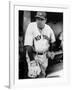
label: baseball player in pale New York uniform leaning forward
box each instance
[24,12,55,78]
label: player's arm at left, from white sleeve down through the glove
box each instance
[24,24,41,78]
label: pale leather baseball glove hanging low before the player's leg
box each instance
[28,60,41,78]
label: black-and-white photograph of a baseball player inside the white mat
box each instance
[18,10,63,79]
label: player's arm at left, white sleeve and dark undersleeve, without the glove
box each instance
[24,24,34,61]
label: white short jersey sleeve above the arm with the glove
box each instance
[24,24,33,46]
